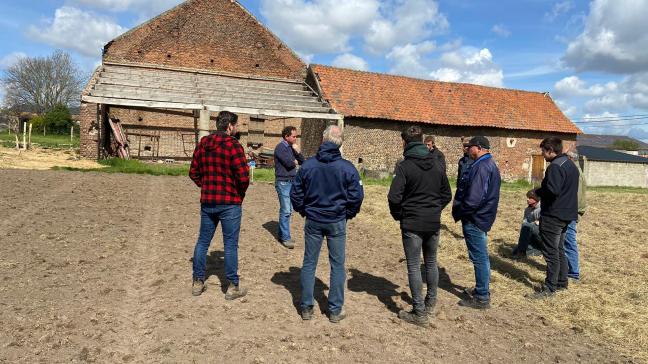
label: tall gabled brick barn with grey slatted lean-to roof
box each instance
[79,0,340,160]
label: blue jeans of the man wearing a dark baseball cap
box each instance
[462,221,490,300]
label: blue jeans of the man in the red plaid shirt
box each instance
[193,203,242,286]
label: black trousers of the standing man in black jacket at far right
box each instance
[540,216,570,292]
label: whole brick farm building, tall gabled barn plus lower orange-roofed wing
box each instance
[79,0,580,180]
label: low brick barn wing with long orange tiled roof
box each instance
[309,65,581,180]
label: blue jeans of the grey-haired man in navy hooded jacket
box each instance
[301,219,346,315]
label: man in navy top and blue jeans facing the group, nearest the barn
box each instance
[274,126,304,249]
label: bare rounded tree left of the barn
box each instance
[2,50,85,113]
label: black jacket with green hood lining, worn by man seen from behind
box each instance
[387,142,452,232]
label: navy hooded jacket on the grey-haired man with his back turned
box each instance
[290,142,364,224]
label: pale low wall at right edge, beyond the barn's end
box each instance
[583,160,648,188]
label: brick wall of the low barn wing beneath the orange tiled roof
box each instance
[343,118,576,180]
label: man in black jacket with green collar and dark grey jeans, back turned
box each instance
[387,126,452,326]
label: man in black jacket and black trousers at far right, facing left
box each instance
[530,137,579,299]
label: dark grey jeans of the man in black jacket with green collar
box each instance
[401,230,439,314]
